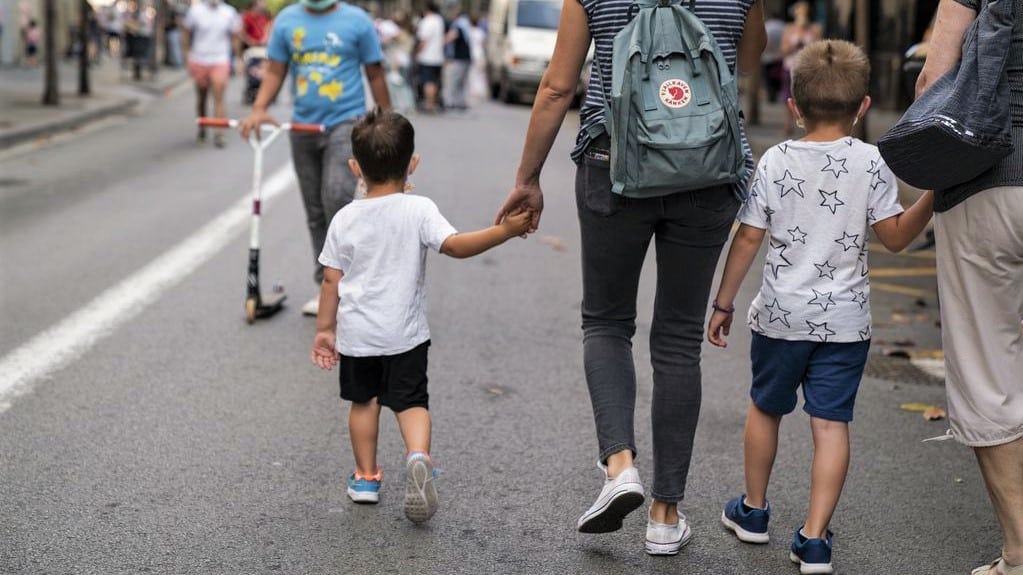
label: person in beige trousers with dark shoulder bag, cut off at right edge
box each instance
[917,0,1023,575]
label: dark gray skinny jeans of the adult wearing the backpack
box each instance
[576,138,739,503]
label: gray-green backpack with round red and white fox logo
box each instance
[590,0,746,197]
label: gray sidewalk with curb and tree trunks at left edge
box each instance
[0,57,187,149]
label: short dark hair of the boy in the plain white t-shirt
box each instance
[352,108,415,183]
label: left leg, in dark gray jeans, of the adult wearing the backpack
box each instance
[576,152,654,477]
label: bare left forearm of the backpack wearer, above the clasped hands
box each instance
[516,77,575,185]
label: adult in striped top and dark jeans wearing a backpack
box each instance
[497,0,764,555]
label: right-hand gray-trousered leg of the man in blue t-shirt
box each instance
[319,121,358,283]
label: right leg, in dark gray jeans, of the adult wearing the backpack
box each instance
[650,186,739,523]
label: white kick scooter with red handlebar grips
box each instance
[196,118,323,323]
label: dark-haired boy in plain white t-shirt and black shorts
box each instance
[312,112,530,523]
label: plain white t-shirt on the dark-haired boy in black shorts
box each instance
[319,193,456,357]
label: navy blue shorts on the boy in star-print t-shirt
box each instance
[750,331,871,422]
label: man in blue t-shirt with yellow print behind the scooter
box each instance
[241,0,391,316]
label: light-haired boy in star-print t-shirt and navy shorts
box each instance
[707,40,932,574]
